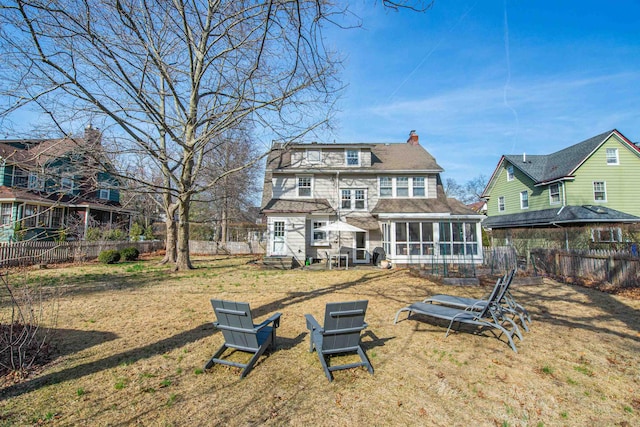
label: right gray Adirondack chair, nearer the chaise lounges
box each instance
[304,300,373,382]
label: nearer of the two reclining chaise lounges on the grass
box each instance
[393,280,522,353]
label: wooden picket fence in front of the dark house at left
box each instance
[0,240,164,268]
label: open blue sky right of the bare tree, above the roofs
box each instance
[327,0,640,184]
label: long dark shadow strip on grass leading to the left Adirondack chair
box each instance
[0,323,212,400]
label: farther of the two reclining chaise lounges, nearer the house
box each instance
[422,269,531,332]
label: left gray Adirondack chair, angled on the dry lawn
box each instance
[204,299,281,378]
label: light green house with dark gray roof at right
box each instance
[482,129,640,241]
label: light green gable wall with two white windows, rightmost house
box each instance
[566,136,640,216]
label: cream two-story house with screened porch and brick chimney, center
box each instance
[262,132,483,264]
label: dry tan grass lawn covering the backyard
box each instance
[0,258,640,426]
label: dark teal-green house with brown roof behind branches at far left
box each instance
[0,126,130,242]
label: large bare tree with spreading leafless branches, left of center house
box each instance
[0,0,341,269]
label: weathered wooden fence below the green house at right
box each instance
[531,249,640,288]
